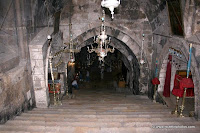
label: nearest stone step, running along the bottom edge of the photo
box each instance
[1,126,200,133]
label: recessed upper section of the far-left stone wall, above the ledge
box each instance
[0,0,20,72]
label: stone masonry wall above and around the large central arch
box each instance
[60,0,152,92]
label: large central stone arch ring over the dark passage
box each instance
[69,26,149,94]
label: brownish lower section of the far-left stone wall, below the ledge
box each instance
[0,62,35,123]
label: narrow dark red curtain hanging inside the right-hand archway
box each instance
[163,55,172,97]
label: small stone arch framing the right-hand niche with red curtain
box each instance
[158,37,200,117]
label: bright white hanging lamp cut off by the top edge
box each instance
[101,0,120,19]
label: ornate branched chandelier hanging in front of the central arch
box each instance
[87,10,115,61]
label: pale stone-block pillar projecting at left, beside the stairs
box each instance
[29,28,53,108]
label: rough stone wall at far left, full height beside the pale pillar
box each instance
[0,0,51,123]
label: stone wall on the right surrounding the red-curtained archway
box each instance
[149,0,200,119]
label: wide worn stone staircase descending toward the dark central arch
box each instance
[0,89,200,133]
